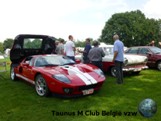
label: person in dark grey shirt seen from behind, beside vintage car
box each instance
[88,41,105,70]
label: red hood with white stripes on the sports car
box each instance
[37,64,100,85]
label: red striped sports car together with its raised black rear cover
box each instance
[10,35,105,96]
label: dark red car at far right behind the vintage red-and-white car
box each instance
[125,46,161,71]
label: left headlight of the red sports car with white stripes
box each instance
[53,74,71,84]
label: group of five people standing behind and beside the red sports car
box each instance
[55,34,124,84]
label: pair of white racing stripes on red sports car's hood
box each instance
[63,66,97,85]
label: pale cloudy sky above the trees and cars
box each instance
[0,0,161,42]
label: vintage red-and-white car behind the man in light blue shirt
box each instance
[76,44,148,76]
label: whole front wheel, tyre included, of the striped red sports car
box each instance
[35,74,50,97]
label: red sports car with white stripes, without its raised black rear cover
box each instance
[11,54,105,96]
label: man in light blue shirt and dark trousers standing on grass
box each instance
[113,34,124,84]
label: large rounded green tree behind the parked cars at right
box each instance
[100,10,159,46]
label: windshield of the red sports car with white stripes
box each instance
[34,55,75,67]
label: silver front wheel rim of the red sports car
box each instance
[35,77,47,96]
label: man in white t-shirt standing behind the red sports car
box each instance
[64,35,76,61]
